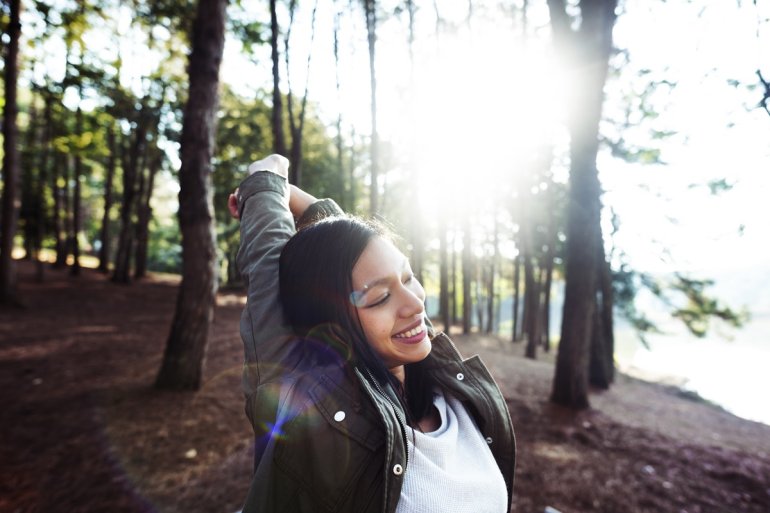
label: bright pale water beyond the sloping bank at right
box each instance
[615,267,770,425]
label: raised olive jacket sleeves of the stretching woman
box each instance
[236,171,342,394]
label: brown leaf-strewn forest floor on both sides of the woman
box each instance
[0,262,770,513]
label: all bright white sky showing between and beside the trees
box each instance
[223,0,770,273]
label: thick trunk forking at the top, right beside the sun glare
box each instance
[548,0,617,409]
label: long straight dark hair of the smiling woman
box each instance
[279,216,433,424]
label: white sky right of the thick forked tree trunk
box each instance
[602,1,770,273]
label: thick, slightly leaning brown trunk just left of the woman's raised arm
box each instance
[155,0,227,390]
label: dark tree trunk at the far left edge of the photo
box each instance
[0,0,21,304]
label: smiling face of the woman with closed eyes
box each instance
[351,237,431,382]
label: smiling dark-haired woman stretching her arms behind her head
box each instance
[229,155,515,513]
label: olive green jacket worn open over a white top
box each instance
[238,172,515,513]
